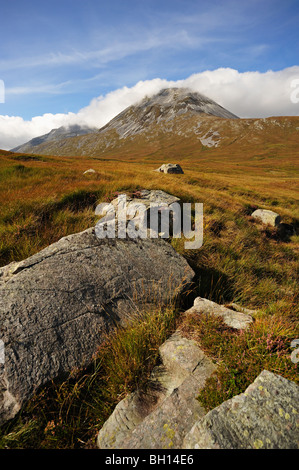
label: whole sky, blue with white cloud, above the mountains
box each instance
[0,0,299,149]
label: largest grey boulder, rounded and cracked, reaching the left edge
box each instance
[0,228,194,424]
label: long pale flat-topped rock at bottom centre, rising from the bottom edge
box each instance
[97,331,216,449]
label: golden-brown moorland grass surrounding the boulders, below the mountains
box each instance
[0,149,299,448]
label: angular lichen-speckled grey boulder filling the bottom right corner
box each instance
[183,370,299,449]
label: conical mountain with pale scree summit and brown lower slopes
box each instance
[9,88,299,161]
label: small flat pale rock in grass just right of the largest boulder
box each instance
[186,297,253,330]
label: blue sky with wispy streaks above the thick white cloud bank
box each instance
[0,0,299,119]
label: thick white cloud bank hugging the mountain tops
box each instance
[0,66,299,149]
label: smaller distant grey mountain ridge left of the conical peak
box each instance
[11,124,97,153]
